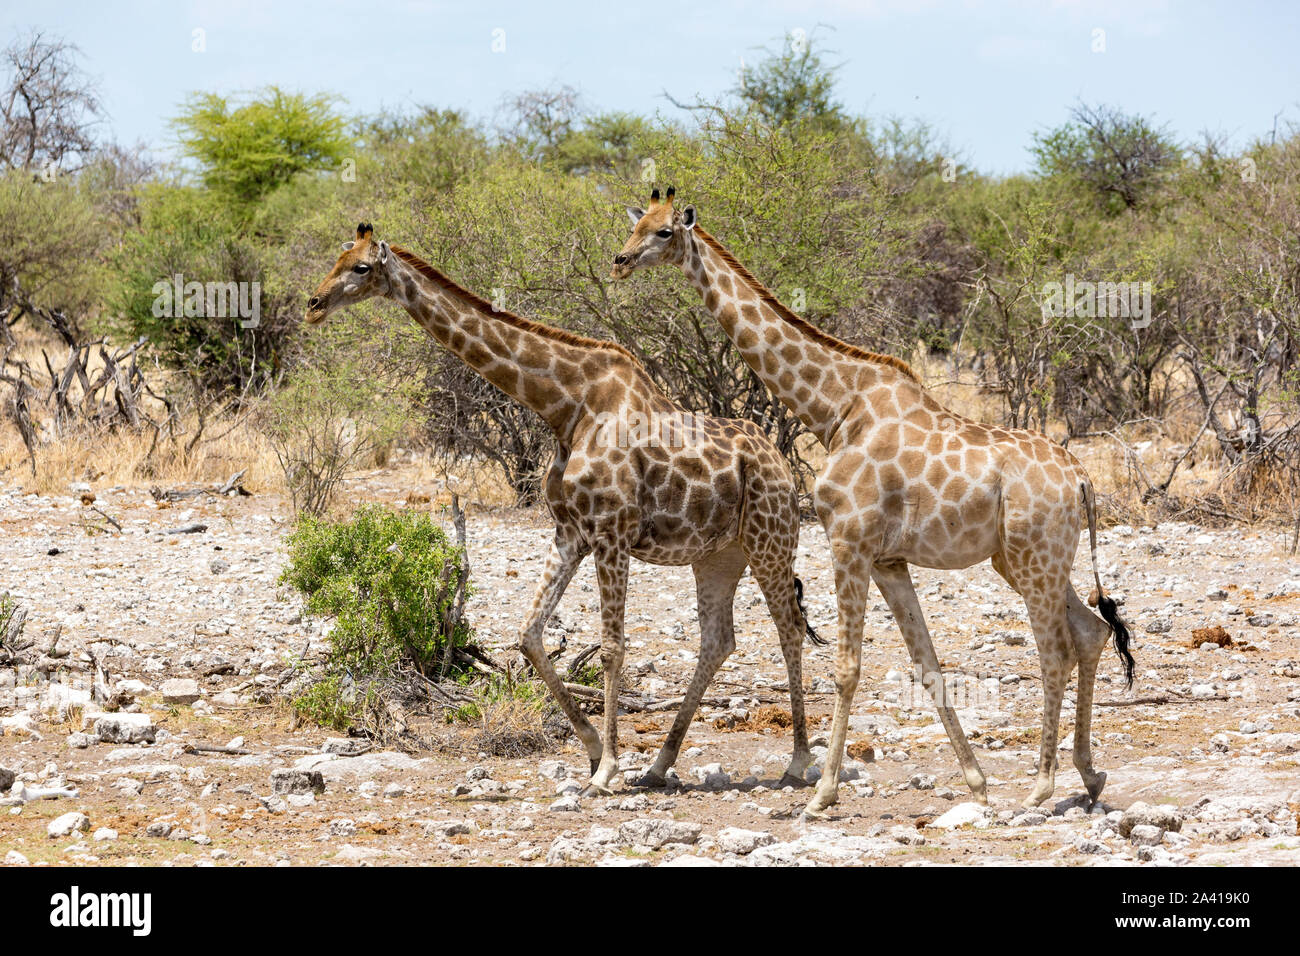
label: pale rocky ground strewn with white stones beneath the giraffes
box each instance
[0,473,1300,866]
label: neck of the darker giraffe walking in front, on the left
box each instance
[386,247,593,442]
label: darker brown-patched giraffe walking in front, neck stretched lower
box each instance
[304,222,826,793]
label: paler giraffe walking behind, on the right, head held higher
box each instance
[611,189,1134,817]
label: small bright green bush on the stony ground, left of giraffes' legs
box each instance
[281,506,472,727]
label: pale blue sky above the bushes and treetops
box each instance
[0,0,1300,173]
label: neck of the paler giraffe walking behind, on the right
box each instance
[681,226,872,447]
